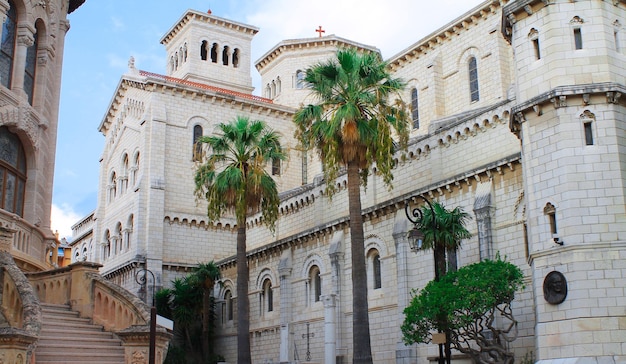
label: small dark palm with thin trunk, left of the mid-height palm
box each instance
[193,261,222,362]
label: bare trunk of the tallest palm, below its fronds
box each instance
[348,163,372,364]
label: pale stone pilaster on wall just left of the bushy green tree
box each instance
[393,215,417,364]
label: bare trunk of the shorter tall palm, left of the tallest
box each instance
[237,226,252,364]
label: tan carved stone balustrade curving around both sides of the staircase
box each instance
[0,242,172,364]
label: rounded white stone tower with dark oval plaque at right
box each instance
[503,0,626,363]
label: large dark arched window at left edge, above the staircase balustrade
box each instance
[0,126,26,216]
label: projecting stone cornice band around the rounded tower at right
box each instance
[509,82,626,137]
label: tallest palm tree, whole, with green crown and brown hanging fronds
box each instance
[294,49,408,363]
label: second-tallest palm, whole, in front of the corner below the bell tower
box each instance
[195,116,286,363]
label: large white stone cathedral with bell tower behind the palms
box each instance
[70,0,626,364]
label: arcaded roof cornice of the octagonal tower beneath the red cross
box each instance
[254,34,380,71]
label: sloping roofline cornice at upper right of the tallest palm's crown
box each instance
[388,0,509,70]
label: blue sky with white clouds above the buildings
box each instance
[51,0,483,240]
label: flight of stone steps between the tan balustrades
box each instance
[35,303,124,364]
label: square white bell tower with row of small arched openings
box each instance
[161,10,258,93]
